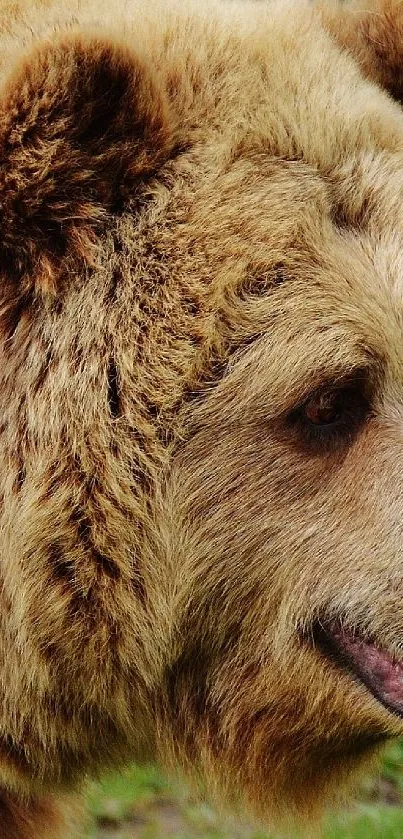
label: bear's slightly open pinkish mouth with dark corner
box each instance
[313,621,403,717]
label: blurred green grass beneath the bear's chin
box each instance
[86,741,403,839]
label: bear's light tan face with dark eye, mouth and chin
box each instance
[161,156,403,810]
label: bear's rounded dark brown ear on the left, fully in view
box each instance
[0,33,174,291]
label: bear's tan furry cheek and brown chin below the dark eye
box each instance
[155,423,403,807]
